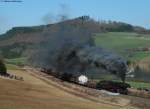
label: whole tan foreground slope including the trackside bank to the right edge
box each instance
[0,66,149,109]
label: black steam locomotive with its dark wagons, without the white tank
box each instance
[41,69,131,95]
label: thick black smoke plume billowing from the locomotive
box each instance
[30,16,127,81]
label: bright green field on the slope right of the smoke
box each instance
[94,32,150,61]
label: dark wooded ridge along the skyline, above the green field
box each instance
[0,16,148,58]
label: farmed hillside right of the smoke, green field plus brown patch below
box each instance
[95,32,150,81]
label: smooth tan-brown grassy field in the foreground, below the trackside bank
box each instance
[0,69,119,109]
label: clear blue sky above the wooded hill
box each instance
[0,0,150,33]
